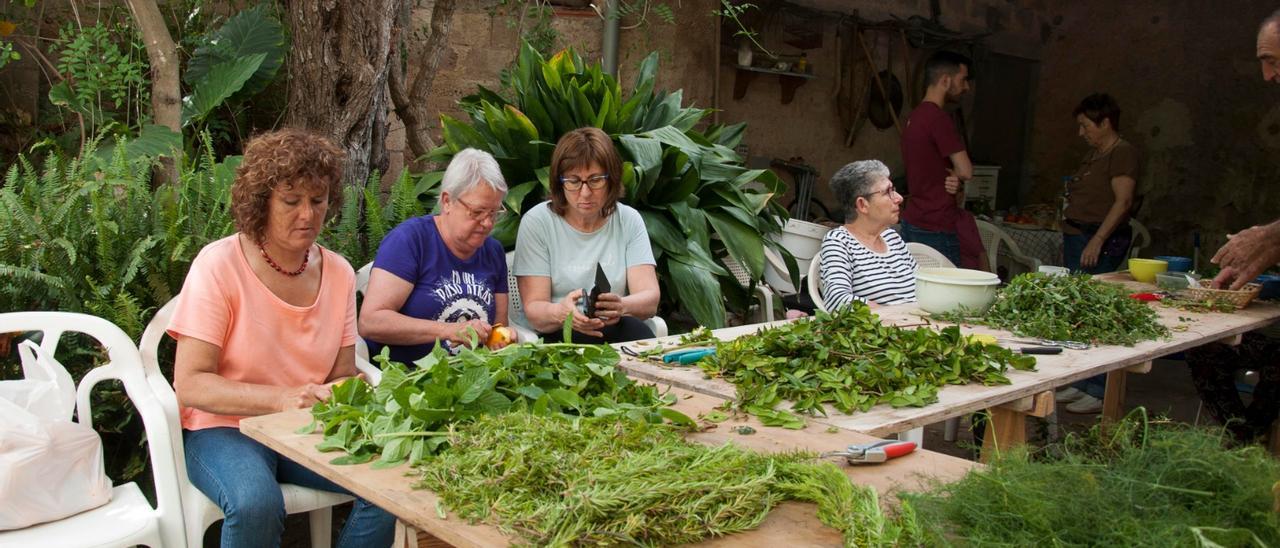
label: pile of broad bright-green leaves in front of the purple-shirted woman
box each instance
[303,343,694,467]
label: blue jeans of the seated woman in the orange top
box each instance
[182,428,396,548]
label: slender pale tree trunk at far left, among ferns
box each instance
[129,0,182,183]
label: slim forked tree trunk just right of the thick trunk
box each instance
[388,0,457,159]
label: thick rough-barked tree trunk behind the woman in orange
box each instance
[284,0,403,186]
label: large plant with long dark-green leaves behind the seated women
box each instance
[431,44,794,326]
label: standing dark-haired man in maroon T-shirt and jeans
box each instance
[902,51,973,265]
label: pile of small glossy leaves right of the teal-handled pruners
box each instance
[700,303,1036,429]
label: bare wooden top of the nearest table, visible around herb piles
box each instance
[241,388,975,547]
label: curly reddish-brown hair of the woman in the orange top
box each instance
[232,128,346,242]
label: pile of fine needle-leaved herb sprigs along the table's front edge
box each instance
[415,414,914,545]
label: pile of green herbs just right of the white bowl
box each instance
[932,273,1169,346]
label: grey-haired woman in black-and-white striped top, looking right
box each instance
[818,160,916,310]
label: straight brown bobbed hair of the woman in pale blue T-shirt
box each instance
[550,127,622,216]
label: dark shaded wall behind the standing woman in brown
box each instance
[1027,0,1280,257]
